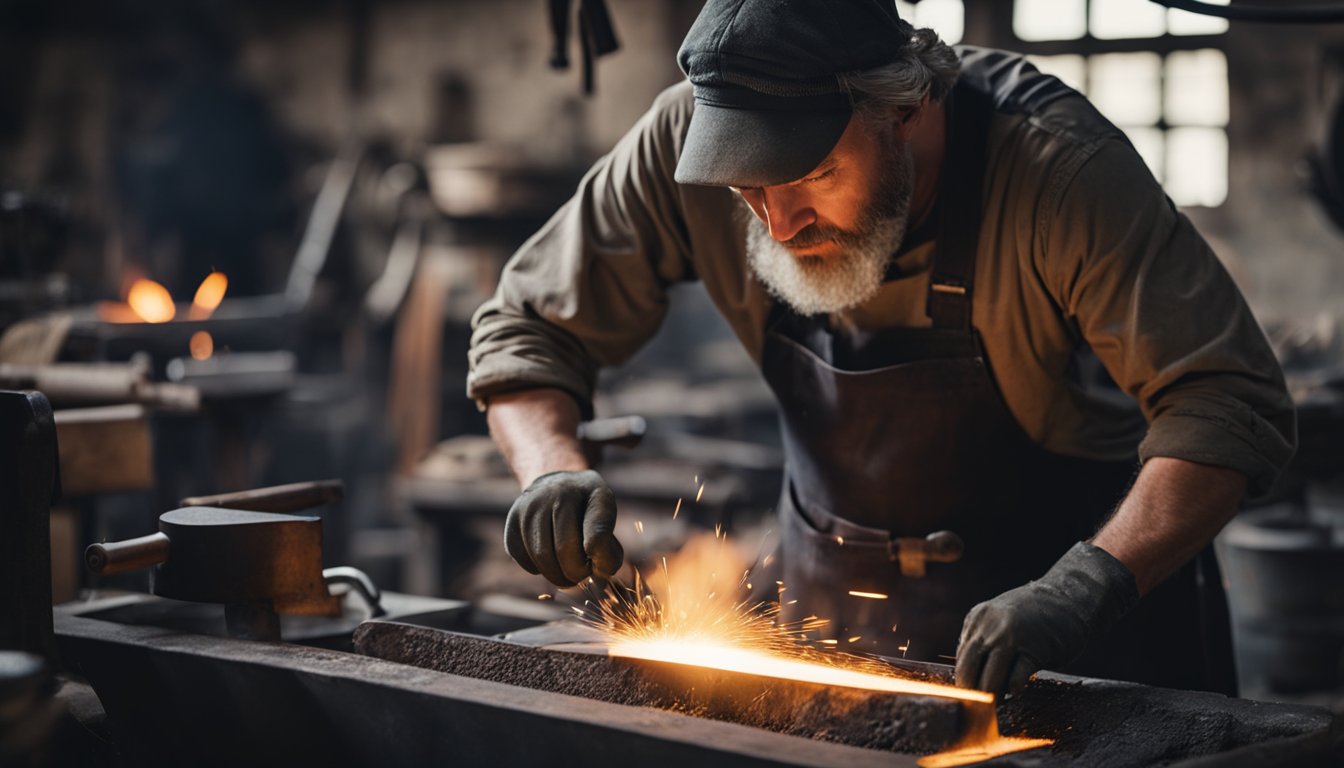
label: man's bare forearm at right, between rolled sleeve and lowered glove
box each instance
[1091,456,1246,594]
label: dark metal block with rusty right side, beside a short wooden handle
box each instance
[153,507,339,613]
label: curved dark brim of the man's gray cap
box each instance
[675,102,852,187]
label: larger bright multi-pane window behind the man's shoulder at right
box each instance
[1013,0,1228,207]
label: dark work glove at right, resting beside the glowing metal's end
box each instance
[957,542,1138,694]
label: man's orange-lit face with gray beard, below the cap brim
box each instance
[738,110,914,315]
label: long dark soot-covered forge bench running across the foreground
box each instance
[55,599,1344,768]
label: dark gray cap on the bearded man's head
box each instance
[675,0,914,187]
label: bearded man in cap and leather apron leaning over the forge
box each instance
[468,0,1294,693]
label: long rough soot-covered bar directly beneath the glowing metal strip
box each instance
[355,621,962,755]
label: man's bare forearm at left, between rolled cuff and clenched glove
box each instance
[485,389,589,488]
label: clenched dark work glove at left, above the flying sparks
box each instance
[504,469,625,586]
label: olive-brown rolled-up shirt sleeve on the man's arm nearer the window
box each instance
[1043,139,1296,496]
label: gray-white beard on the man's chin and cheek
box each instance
[743,147,914,315]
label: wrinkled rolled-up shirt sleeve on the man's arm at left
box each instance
[466,89,694,412]
